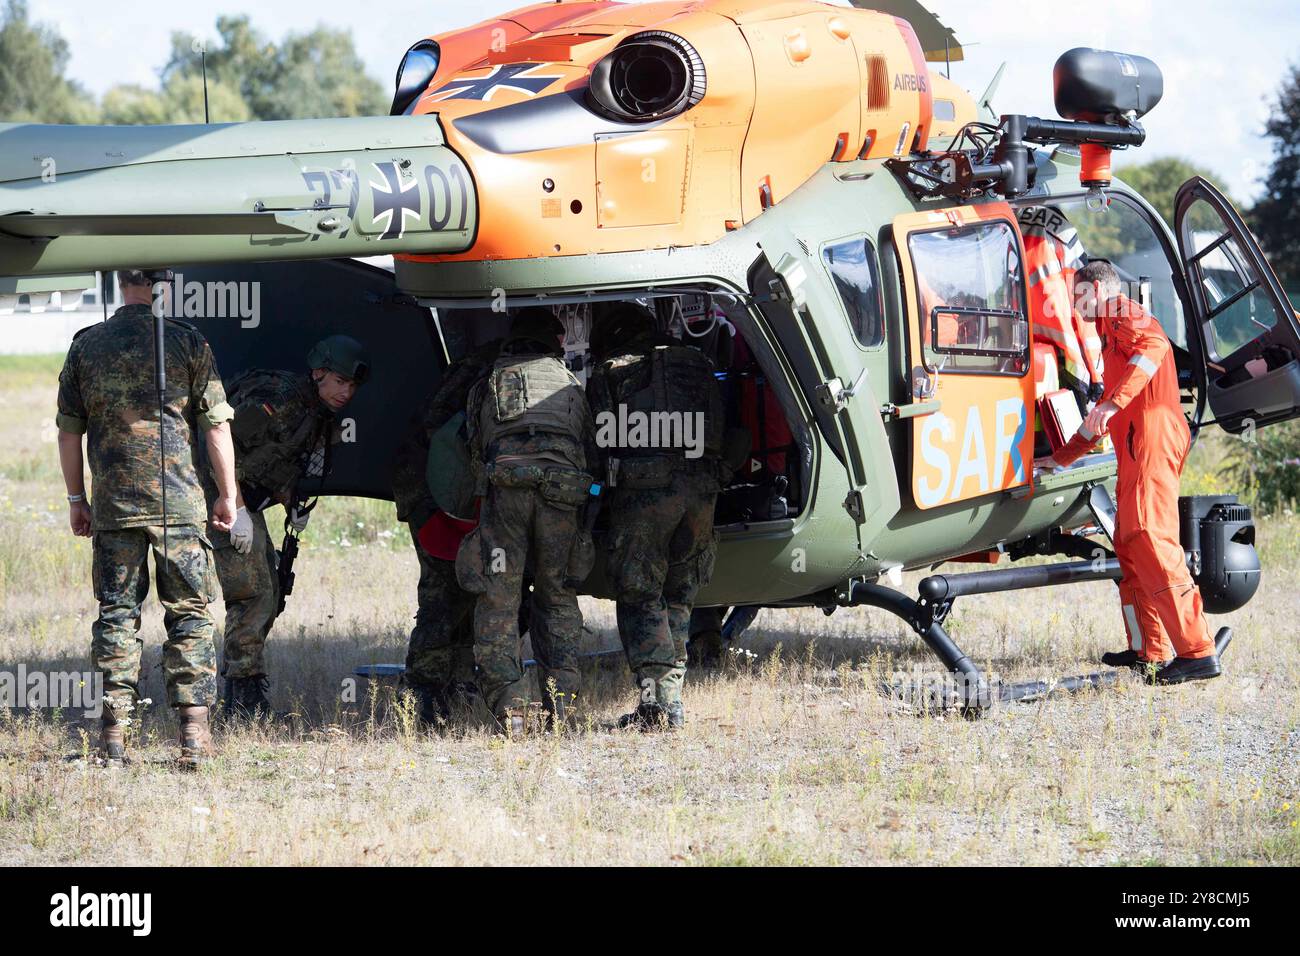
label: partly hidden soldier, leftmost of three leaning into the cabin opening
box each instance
[393,339,501,724]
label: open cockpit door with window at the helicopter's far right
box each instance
[1174,177,1300,433]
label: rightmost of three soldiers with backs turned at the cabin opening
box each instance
[588,303,725,730]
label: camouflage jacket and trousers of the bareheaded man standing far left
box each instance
[56,306,233,714]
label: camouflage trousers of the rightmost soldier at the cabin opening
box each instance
[608,472,718,705]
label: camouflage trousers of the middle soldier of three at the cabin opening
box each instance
[456,484,590,717]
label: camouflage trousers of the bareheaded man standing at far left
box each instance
[91,524,217,715]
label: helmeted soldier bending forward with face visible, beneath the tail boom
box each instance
[204,336,371,717]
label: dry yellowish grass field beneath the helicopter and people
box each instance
[0,358,1300,865]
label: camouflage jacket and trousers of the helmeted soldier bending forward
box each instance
[203,368,339,679]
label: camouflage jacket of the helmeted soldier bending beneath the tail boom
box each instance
[220,368,341,509]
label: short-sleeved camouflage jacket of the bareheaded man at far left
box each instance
[55,306,234,531]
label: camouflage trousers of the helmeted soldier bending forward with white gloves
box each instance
[212,511,280,679]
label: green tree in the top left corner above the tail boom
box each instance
[0,0,99,124]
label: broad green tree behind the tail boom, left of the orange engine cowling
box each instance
[163,16,390,121]
